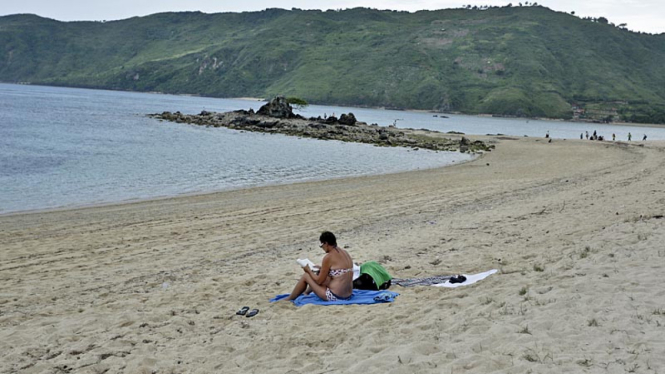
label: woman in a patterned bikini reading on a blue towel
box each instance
[287,231,353,301]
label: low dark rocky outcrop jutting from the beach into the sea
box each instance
[150,106,494,153]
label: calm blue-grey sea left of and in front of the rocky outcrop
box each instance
[0,84,471,214]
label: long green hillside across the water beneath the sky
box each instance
[0,6,665,123]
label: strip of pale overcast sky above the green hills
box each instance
[0,0,665,34]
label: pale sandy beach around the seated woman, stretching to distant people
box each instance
[0,137,665,373]
